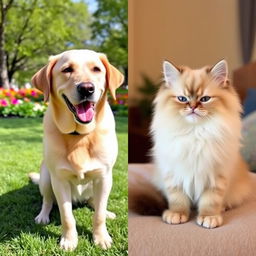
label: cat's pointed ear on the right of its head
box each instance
[210,60,228,86]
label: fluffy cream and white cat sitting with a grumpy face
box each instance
[151,60,250,228]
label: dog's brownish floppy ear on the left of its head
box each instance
[31,55,58,101]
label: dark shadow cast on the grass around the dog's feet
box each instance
[0,183,92,243]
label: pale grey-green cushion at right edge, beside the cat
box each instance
[241,111,256,171]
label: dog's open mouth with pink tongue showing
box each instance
[62,94,95,124]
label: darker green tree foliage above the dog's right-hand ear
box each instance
[91,0,128,82]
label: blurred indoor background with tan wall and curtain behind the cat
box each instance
[128,0,256,163]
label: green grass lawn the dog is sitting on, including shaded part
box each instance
[0,117,128,256]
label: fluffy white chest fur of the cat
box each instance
[158,123,233,202]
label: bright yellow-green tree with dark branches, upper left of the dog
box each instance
[0,0,90,87]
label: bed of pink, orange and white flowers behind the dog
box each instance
[0,88,128,117]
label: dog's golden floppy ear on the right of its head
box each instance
[100,53,124,99]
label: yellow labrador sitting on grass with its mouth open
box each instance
[30,50,123,250]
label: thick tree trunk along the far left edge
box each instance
[0,3,10,89]
